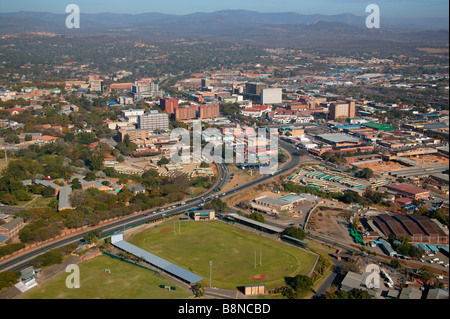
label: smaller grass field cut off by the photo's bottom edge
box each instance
[21,256,193,299]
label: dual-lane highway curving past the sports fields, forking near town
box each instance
[0,141,300,272]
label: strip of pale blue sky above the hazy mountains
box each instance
[0,0,449,18]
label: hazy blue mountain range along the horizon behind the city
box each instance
[0,10,448,45]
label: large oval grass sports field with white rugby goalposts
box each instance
[126,221,317,290]
